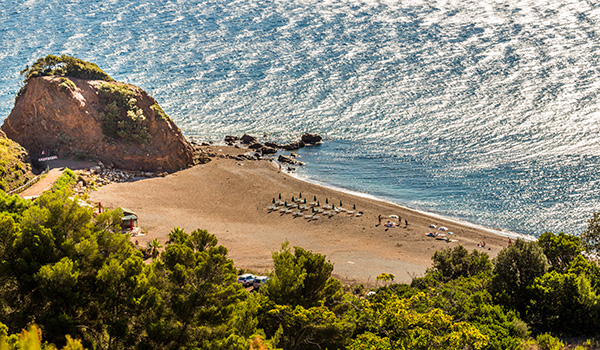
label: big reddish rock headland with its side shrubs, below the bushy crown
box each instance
[2,76,194,172]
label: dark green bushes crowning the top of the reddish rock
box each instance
[21,55,114,81]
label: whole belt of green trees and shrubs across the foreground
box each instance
[0,189,600,350]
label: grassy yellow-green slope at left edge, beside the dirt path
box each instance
[0,137,33,191]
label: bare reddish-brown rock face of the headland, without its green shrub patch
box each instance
[2,77,193,172]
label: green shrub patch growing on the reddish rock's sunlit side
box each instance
[98,83,150,144]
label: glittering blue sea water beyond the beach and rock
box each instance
[0,0,600,235]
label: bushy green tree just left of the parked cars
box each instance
[146,228,247,349]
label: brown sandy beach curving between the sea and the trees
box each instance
[90,146,508,286]
